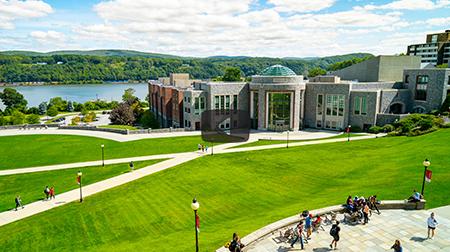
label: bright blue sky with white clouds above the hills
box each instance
[0,0,450,57]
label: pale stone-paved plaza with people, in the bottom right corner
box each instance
[245,206,450,252]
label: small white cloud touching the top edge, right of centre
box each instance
[268,0,336,12]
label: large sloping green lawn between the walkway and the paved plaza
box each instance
[0,129,450,251]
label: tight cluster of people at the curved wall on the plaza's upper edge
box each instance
[345,195,380,225]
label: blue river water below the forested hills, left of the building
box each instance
[0,83,148,108]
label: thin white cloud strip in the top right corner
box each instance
[363,0,450,10]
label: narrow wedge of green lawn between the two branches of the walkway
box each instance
[0,160,162,212]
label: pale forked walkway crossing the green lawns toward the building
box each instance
[0,135,384,226]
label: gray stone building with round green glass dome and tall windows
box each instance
[151,60,450,131]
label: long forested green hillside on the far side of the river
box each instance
[0,50,369,83]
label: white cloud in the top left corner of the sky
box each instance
[0,0,53,29]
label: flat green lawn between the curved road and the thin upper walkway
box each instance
[0,135,202,170]
